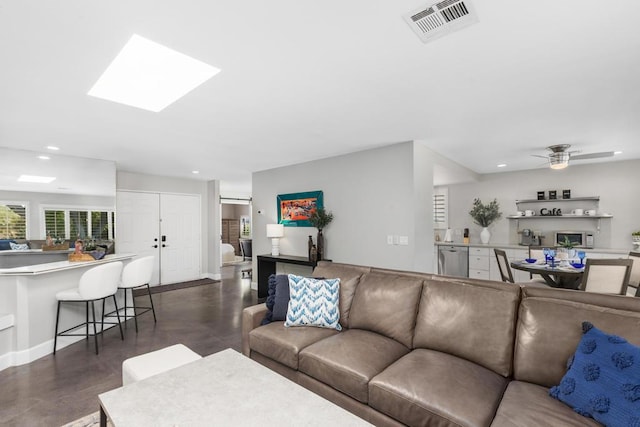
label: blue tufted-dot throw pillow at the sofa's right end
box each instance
[549,322,640,427]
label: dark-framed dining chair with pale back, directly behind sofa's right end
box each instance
[580,258,633,295]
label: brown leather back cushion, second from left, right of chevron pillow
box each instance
[349,273,423,347]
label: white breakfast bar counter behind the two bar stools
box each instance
[0,254,135,370]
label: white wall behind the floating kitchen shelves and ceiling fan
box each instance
[441,160,640,251]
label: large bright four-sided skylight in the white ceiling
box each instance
[89,34,220,112]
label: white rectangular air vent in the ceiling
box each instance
[403,0,478,43]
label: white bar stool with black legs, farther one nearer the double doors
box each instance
[107,255,157,333]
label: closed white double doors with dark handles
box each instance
[116,191,202,285]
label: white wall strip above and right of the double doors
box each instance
[116,171,220,278]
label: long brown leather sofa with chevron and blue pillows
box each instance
[242,262,640,427]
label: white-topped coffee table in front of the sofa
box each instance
[98,349,371,427]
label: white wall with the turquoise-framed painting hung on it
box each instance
[252,142,433,271]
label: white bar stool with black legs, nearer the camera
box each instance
[53,261,124,354]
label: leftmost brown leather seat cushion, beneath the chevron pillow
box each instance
[249,322,338,369]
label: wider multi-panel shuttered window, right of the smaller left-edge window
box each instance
[44,208,115,240]
